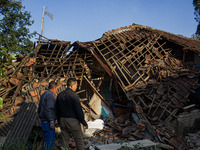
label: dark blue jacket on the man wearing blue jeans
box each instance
[38,90,56,121]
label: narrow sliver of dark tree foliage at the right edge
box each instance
[193,0,200,39]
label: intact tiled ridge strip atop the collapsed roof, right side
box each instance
[102,24,200,52]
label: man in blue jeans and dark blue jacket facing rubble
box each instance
[38,81,57,150]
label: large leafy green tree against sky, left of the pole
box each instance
[0,0,35,54]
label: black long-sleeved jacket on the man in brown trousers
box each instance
[56,88,87,126]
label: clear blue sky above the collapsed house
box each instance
[22,0,197,43]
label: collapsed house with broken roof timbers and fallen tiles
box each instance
[0,24,200,149]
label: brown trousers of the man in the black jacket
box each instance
[60,118,85,150]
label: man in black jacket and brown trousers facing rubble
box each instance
[56,78,88,150]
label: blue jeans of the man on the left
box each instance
[41,120,55,150]
